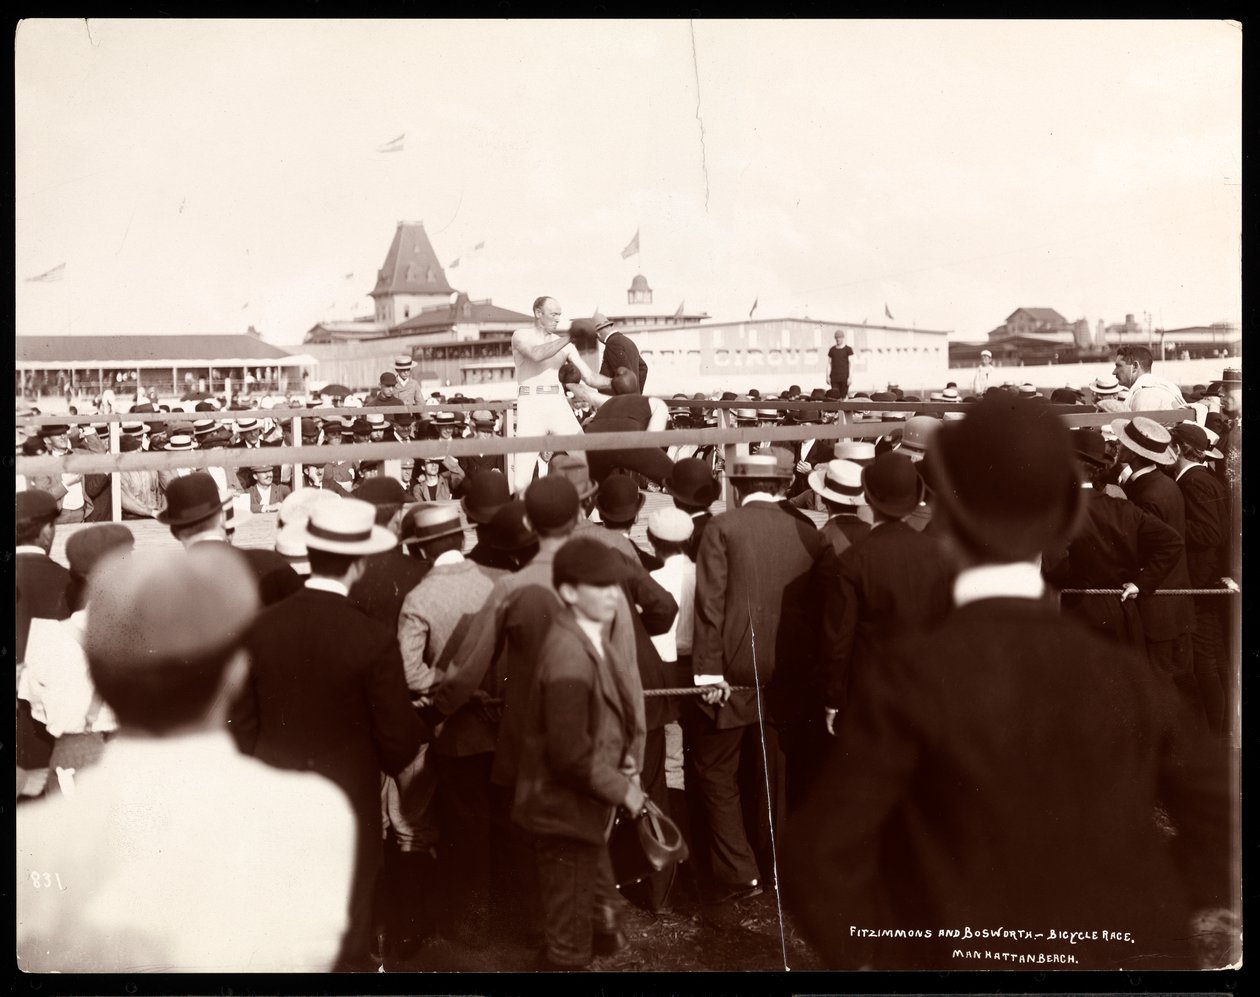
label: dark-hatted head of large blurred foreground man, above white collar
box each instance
[929,395,1085,562]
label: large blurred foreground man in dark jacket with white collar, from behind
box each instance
[781,397,1240,971]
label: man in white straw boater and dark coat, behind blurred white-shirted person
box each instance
[235,496,431,972]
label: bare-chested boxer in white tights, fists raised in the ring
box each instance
[508,296,612,492]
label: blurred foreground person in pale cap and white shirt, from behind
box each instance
[16,545,354,973]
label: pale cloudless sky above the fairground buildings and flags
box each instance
[15,20,1242,345]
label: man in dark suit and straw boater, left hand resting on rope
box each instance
[684,449,825,902]
